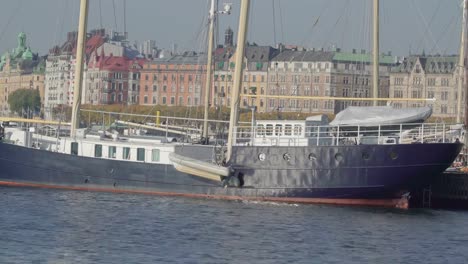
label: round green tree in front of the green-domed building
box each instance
[8,89,41,115]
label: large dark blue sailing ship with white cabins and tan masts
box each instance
[0,0,462,208]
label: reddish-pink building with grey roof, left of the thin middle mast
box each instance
[139,52,207,106]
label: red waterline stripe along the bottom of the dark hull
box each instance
[0,181,408,209]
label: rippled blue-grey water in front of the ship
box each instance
[0,188,468,264]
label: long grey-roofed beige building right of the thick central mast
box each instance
[266,48,394,114]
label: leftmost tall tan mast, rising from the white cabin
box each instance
[71,0,88,138]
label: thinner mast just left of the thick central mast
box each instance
[203,0,216,143]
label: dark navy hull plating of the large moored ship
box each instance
[0,143,461,207]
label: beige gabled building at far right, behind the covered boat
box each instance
[390,56,465,117]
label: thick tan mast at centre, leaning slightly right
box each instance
[226,0,250,160]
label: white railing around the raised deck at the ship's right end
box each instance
[234,123,462,146]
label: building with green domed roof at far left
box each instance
[0,32,45,116]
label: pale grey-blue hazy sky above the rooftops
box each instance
[0,0,462,55]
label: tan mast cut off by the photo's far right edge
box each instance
[457,0,468,124]
